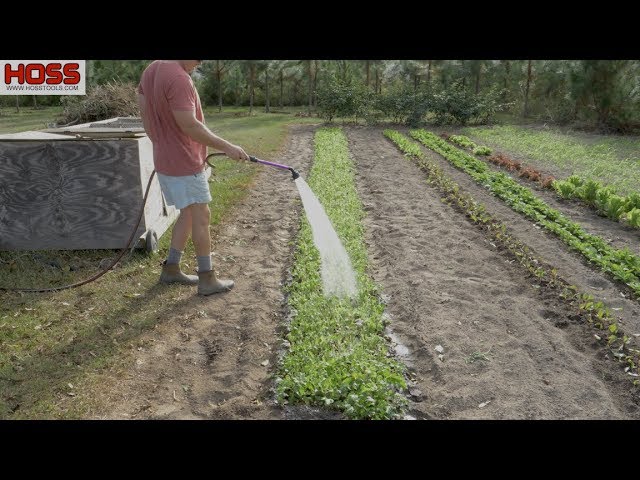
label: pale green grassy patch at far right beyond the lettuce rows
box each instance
[462,125,640,195]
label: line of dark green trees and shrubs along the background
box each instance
[5,60,640,133]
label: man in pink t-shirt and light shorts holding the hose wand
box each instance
[138,60,249,295]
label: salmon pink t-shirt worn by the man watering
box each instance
[138,60,207,176]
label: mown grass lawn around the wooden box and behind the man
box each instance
[0,104,317,419]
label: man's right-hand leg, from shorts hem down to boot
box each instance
[189,203,234,295]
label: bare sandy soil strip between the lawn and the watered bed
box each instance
[96,127,313,419]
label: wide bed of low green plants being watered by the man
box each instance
[276,128,406,419]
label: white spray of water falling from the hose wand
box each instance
[296,177,358,297]
